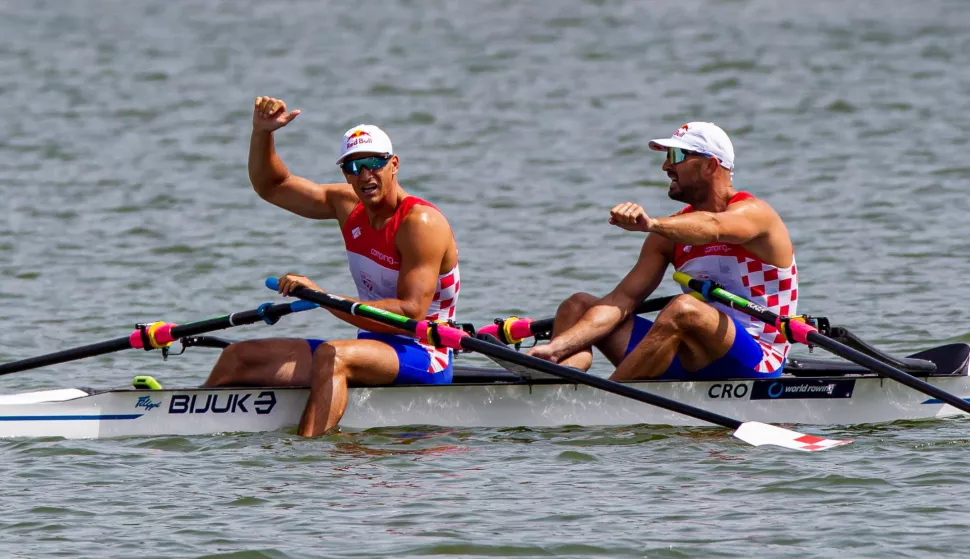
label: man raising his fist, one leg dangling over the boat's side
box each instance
[205,97,460,436]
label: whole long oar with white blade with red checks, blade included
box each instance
[266,278,851,451]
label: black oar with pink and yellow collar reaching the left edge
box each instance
[0,301,318,375]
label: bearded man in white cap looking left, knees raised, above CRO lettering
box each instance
[530,122,798,380]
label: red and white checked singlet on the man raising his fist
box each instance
[341,196,460,372]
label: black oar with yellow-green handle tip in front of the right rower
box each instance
[674,272,970,413]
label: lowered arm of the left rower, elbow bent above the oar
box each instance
[322,206,452,334]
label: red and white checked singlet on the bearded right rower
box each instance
[674,192,798,373]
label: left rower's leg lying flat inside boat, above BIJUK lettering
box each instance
[203,338,311,386]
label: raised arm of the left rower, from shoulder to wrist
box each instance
[249,130,357,223]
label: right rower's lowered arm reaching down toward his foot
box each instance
[552,235,673,357]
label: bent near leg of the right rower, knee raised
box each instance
[610,295,737,380]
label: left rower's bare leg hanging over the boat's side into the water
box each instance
[297,340,398,437]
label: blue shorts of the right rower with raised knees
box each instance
[624,316,785,380]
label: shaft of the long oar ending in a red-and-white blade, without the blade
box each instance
[266,278,742,429]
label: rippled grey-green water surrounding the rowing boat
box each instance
[0,0,970,558]
